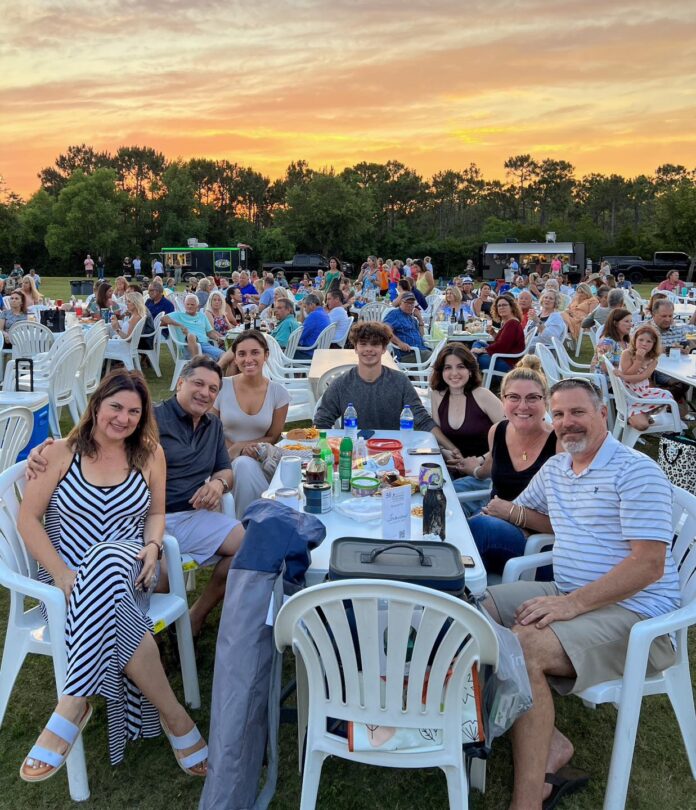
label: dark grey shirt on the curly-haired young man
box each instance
[314,367,435,430]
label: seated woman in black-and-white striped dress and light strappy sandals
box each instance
[18,370,207,782]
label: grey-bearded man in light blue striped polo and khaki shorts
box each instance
[484,379,681,808]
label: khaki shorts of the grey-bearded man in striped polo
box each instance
[488,582,675,695]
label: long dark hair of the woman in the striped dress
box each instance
[67,369,159,470]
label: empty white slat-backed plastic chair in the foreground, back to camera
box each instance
[275,579,498,810]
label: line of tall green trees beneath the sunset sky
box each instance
[0,144,696,275]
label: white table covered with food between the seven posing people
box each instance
[270,430,486,595]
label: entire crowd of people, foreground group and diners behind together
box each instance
[2,257,694,808]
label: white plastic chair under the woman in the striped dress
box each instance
[0,462,201,801]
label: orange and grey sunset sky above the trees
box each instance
[0,0,696,196]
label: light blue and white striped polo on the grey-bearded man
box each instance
[515,434,681,616]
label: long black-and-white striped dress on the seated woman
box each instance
[39,454,160,765]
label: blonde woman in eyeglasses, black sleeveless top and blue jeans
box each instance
[469,354,561,574]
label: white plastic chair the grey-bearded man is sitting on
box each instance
[503,487,696,810]
